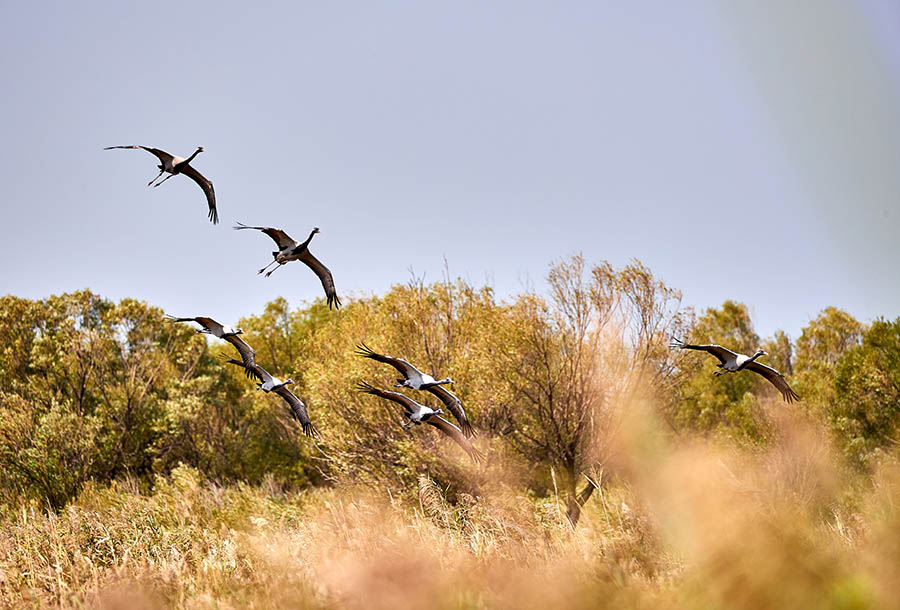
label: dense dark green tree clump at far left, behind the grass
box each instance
[0,291,316,507]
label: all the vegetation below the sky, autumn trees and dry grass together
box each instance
[0,256,900,608]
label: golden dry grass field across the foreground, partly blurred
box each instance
[0,406,900,609]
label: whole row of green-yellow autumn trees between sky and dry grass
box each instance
[0,255,900,523]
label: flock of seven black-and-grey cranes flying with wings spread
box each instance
[104,145,800,463]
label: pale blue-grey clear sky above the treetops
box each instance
[0,0,900,337]
